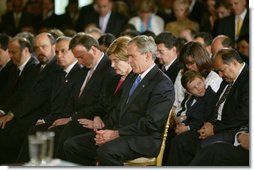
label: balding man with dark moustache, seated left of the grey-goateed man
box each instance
[0,37,38,163]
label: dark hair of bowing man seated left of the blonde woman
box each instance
[69,33,100,50]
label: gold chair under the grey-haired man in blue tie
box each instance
[124,107,175,166]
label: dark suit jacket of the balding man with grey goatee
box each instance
[11,58,61,122]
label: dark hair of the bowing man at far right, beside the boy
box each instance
[215,48,243,64]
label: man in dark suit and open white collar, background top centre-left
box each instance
[76,0,127,36]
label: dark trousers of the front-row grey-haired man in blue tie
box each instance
[64,132,141,166]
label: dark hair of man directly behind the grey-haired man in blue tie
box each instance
[155,32,179,51]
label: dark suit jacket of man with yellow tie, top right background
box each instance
[215,10,249,41]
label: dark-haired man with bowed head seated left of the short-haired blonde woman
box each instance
[42,34,116,159]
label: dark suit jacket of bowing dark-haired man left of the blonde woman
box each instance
[63,55,116,120]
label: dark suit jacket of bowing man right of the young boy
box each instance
[214,64,249,133]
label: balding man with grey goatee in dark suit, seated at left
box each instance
[0,33,59,162]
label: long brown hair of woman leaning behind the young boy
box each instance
[179,42,212,77]
